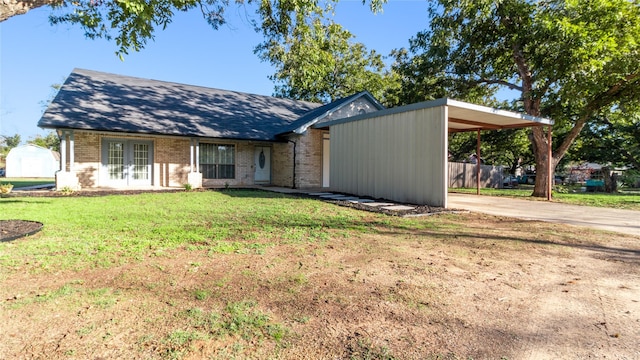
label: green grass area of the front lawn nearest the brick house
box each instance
[0,190,404,271]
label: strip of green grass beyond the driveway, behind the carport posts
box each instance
[449,185,640,211]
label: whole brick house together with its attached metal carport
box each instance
[38,69,553,207]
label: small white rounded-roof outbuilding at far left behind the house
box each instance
[5,144,60,178]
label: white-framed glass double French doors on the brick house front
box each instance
[102,139,153,187]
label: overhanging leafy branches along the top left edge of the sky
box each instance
[0,0,386,58]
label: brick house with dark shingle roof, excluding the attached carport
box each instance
[38,69,383,189]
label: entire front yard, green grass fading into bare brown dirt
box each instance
[0,190,640,359]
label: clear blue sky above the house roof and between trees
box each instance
[0,0,427,142]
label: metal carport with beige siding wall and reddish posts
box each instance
[318,98,553,207]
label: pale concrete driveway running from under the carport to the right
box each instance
[448,193,640,236]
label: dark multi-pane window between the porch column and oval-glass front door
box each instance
[200,144,236,179]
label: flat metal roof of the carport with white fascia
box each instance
[318,98,553,132]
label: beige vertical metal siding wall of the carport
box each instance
[331,106,448,206]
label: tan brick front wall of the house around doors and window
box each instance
[63,129,327,189]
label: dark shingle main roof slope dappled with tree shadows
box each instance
[38,69,322,140]
